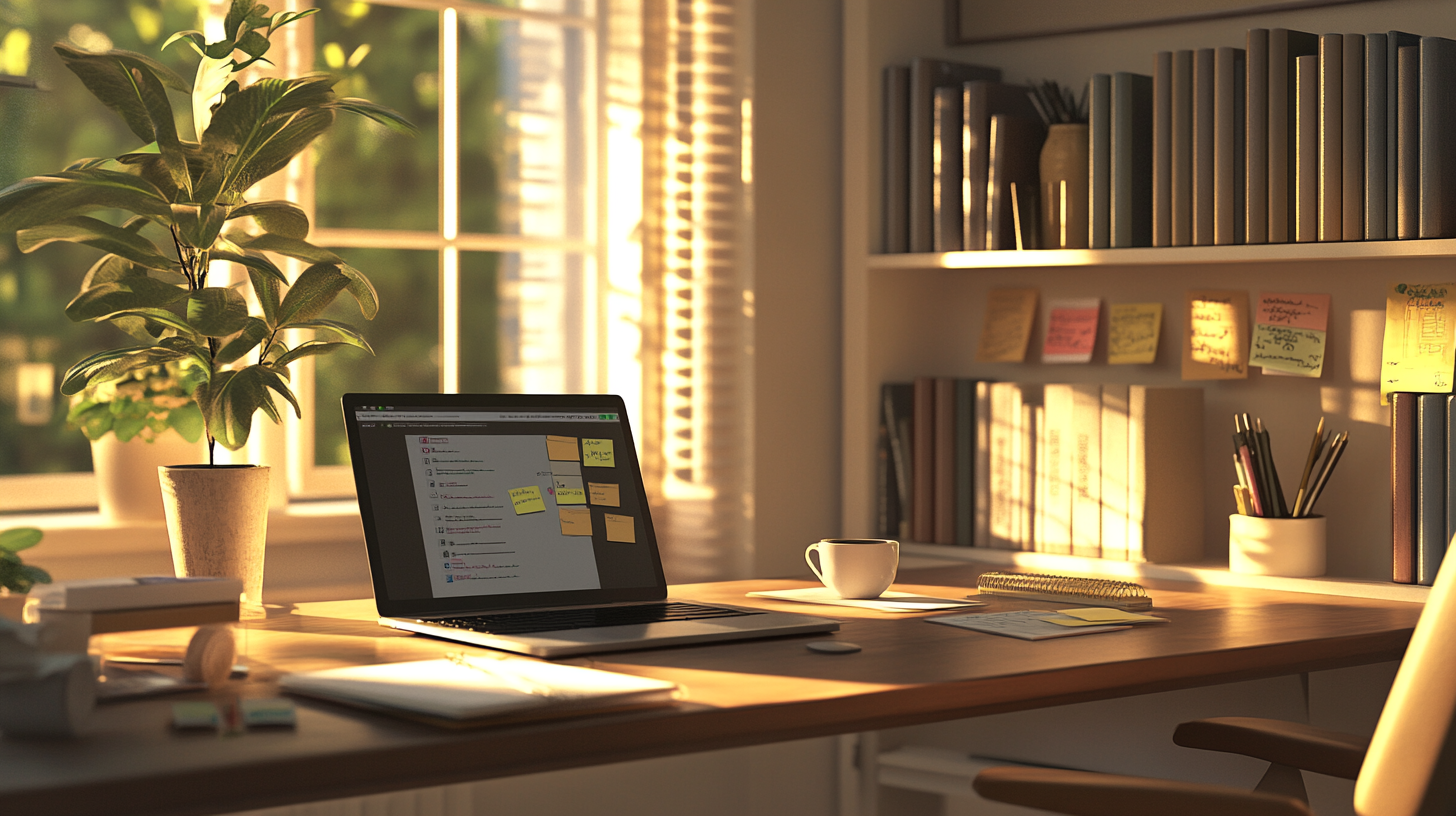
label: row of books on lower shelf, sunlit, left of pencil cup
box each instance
[878,377,1203,562]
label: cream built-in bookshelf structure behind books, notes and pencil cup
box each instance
[842,0,1456,588]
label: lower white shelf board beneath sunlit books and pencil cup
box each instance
[900,542,1431,603]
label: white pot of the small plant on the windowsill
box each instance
[92,428,207,522]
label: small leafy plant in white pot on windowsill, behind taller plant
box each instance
[66,360,205,522]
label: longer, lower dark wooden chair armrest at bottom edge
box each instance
[971,768,1312,816]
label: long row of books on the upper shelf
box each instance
[882,29,1456,252]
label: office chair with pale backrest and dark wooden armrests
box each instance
[973,554,1456,816]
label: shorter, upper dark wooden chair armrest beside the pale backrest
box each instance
[1174,717,1370,780]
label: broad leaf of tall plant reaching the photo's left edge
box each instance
[0,168,172,232]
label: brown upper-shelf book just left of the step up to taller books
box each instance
[1213,47,1245,245]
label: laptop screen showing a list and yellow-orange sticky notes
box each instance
[344,393,665,616]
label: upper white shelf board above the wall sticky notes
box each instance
[866,238,1456,270]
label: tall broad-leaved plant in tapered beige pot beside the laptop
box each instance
[0,0,414,603]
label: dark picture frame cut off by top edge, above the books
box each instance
[945,0,1372,45]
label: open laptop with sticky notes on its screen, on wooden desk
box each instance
[344,393,839,657]
